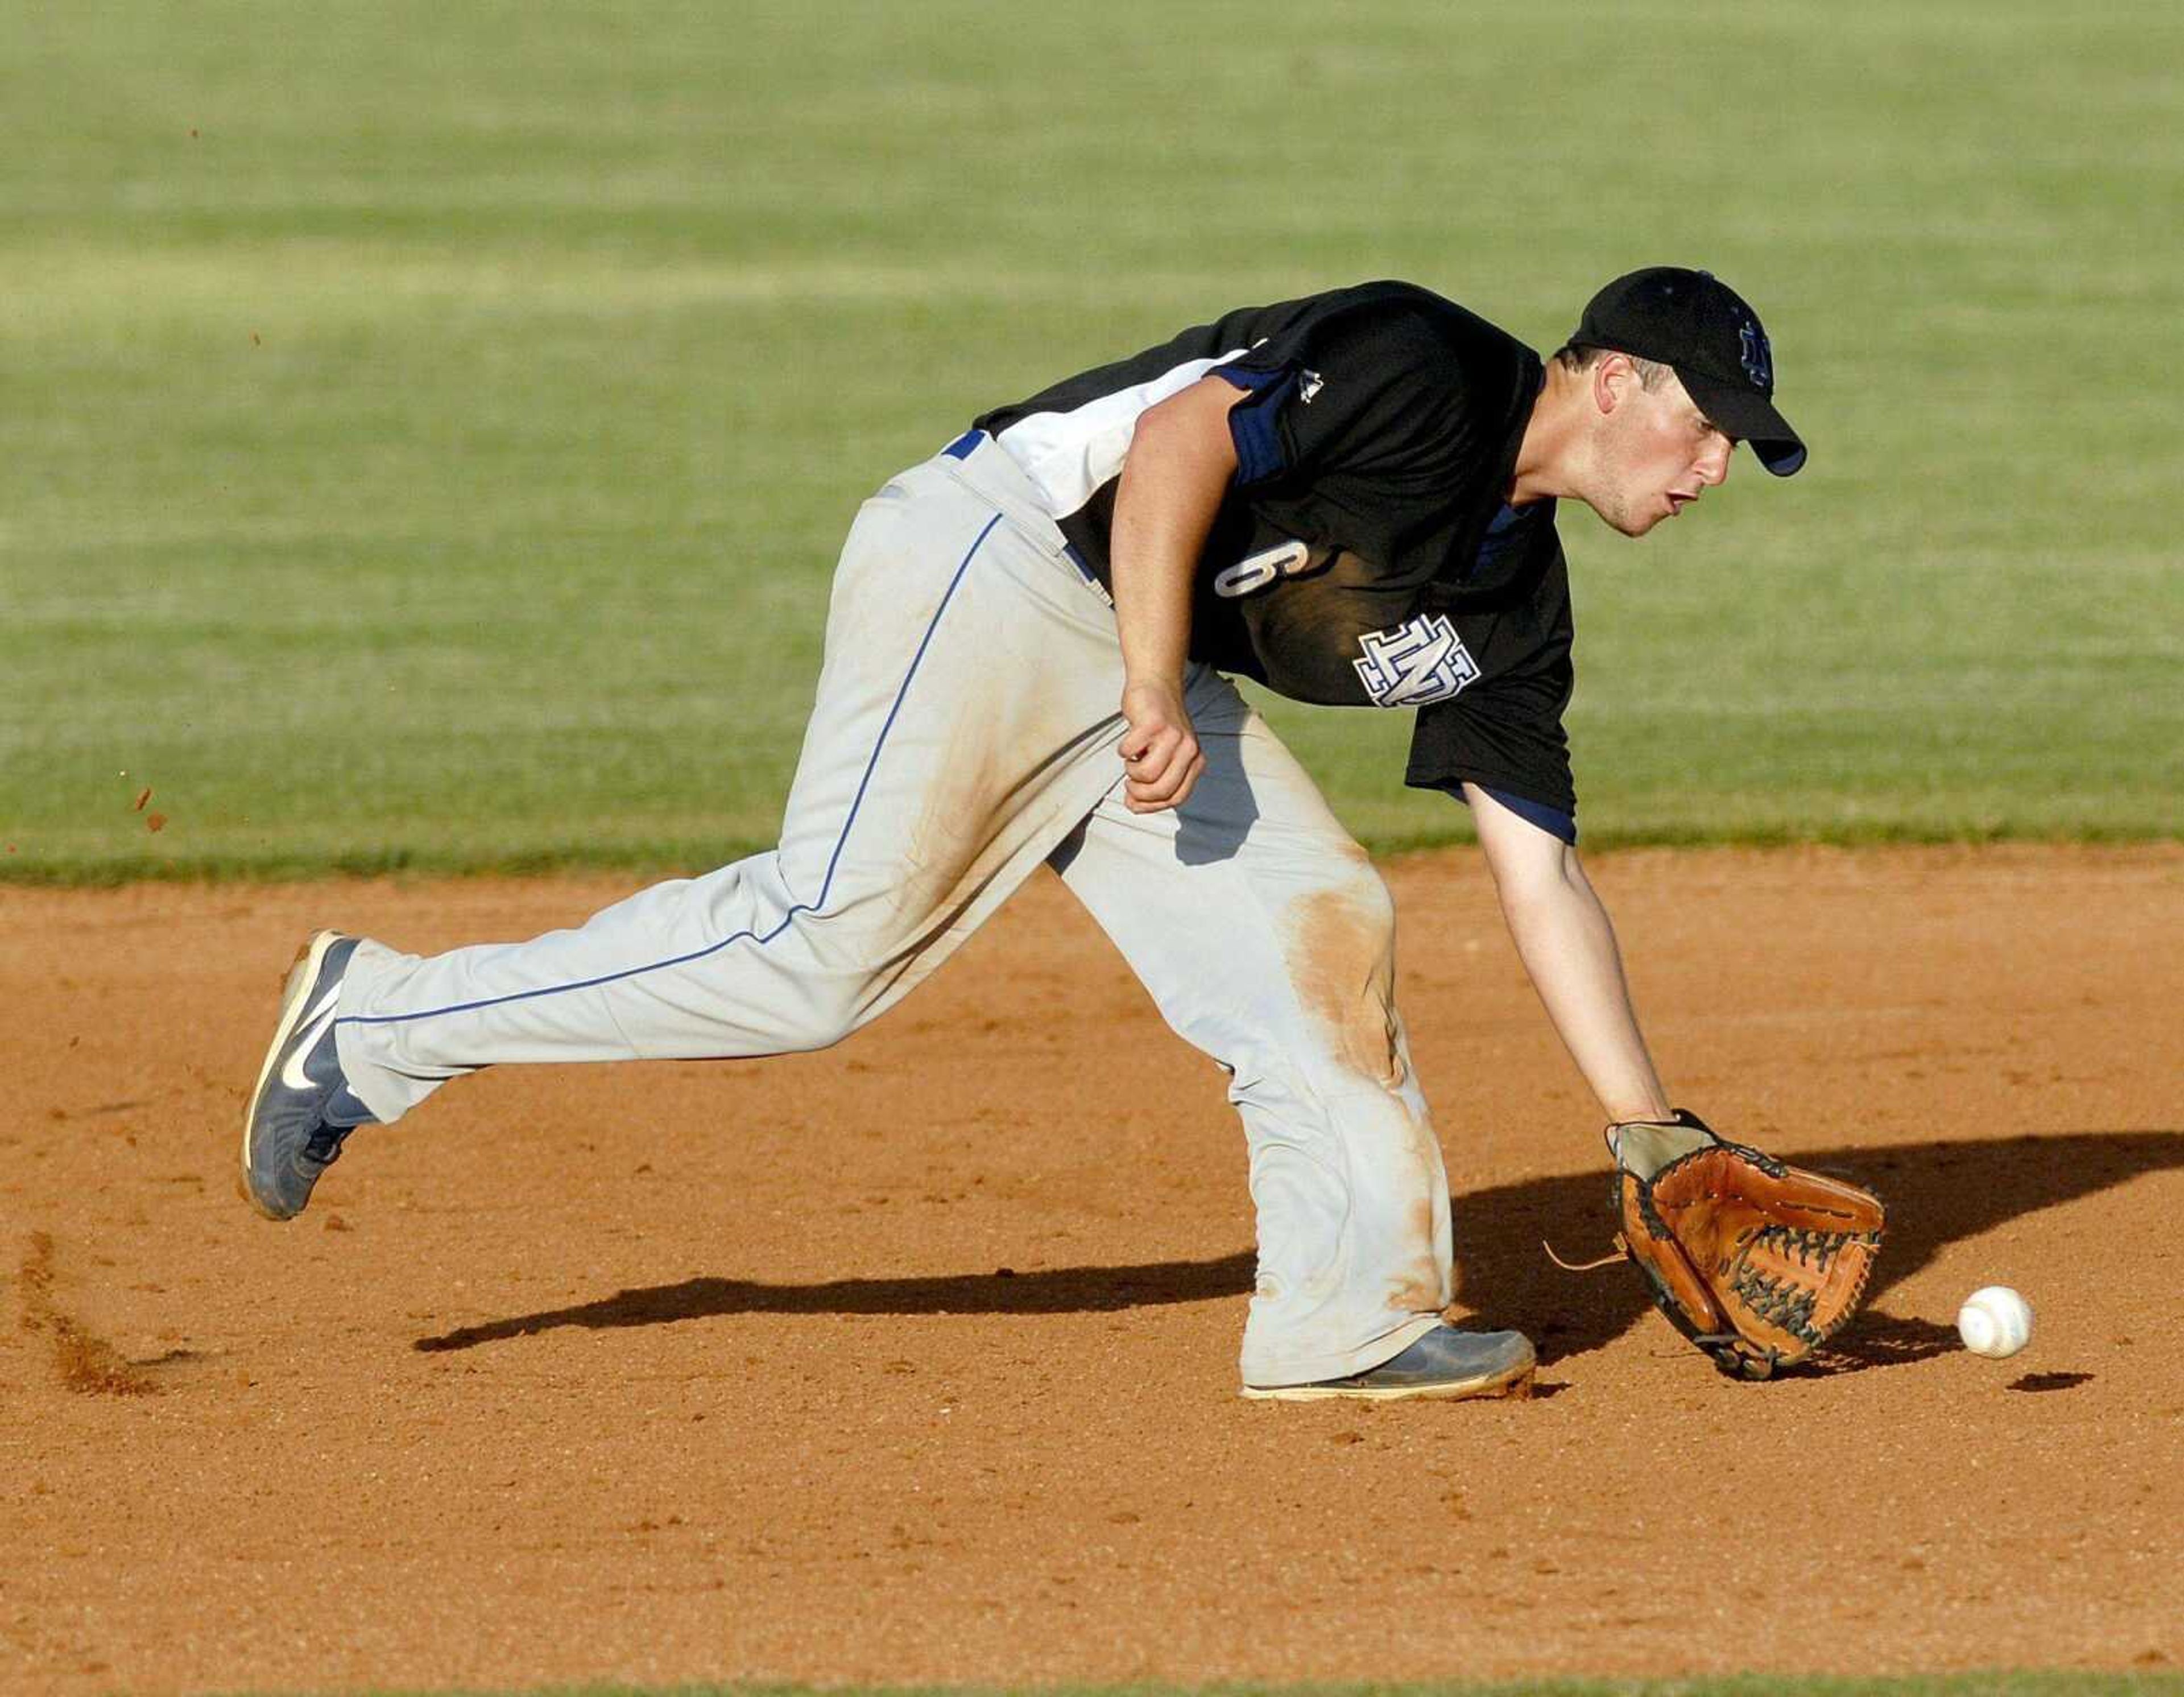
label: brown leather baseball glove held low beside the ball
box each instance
[1607,1109,1885,1378]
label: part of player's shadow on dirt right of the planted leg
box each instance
[1457,1132,2184,1374]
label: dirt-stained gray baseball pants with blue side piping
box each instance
[336,439,1450,1387]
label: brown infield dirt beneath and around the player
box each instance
[0,848,2184,1692]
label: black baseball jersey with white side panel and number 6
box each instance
[976,282,1577,836]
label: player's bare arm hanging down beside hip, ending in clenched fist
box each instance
[1110,378,1236,812]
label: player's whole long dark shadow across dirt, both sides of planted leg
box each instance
[413,1132,2184,1376]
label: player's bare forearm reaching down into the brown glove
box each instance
[1463,784,1669,1120]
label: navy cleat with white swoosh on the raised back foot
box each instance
[242,930,371,1219]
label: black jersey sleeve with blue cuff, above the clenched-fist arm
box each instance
[1212,295,1470,492]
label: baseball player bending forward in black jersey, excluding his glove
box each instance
[242,269,1804,1400]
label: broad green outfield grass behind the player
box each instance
[0,0,2184,880]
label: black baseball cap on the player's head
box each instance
[1570,265,1804,478]
